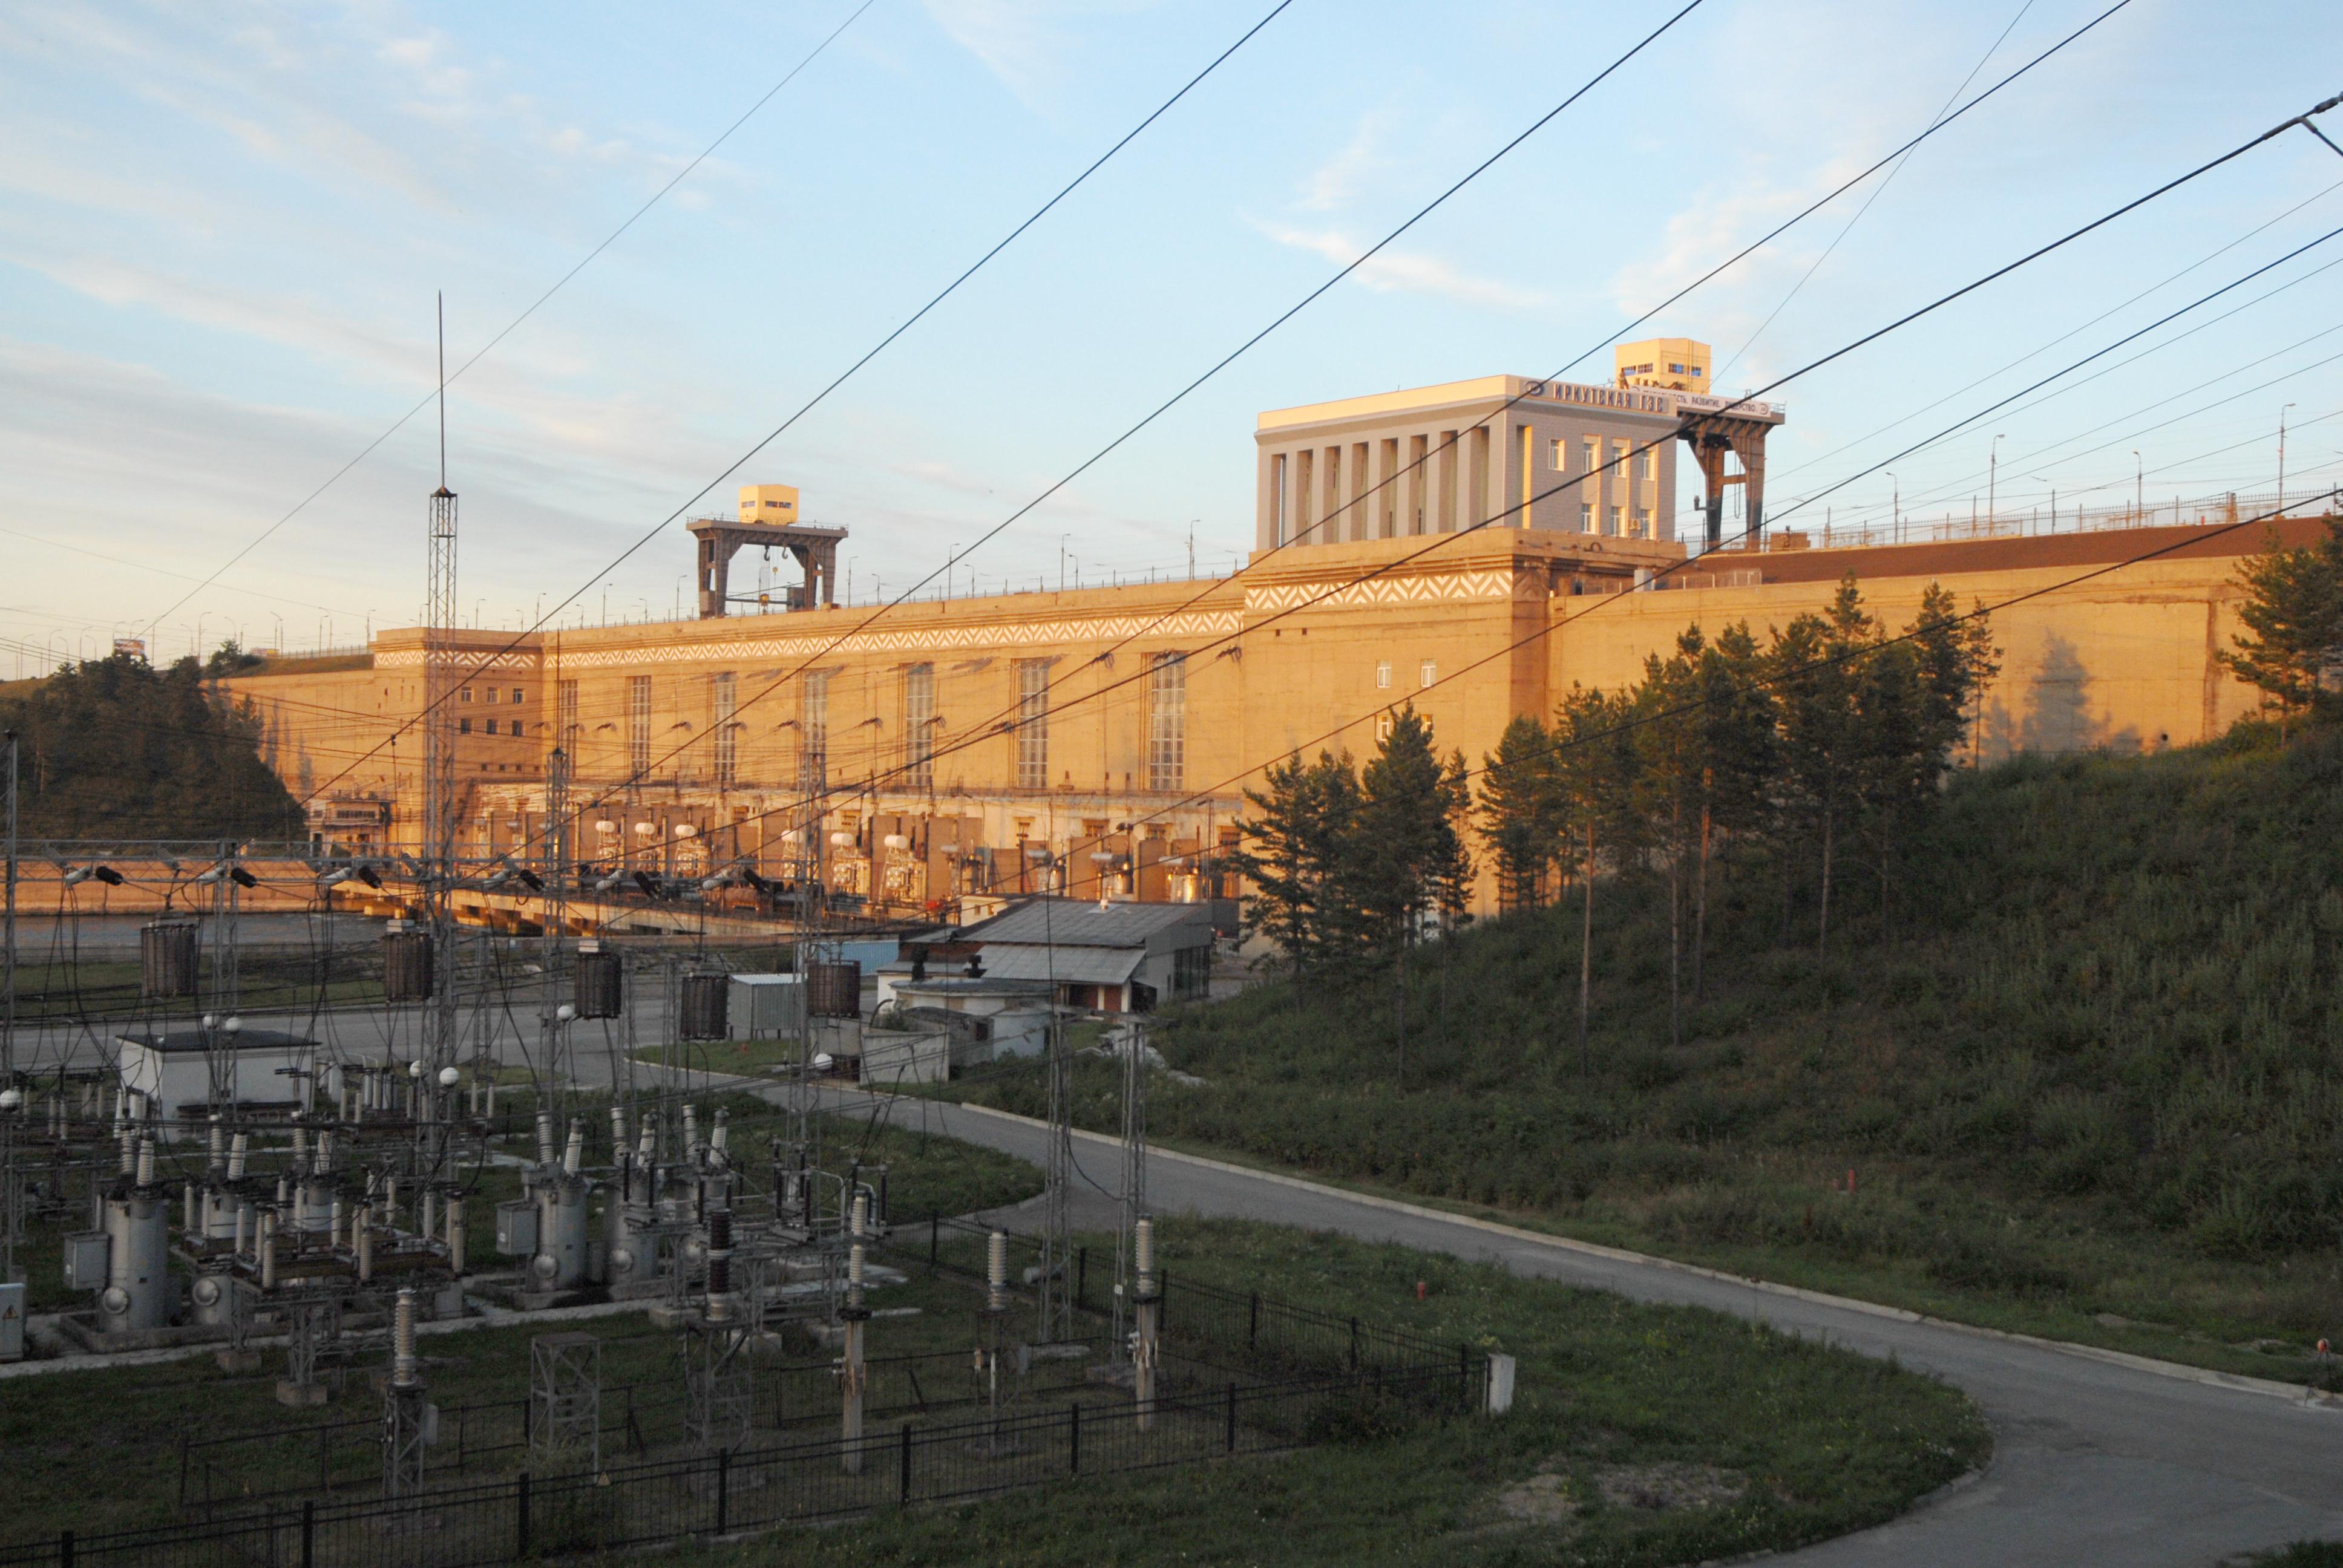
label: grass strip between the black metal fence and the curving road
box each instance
[632,1221,1989,1568]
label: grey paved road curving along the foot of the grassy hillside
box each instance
[810,1082,2343,1568]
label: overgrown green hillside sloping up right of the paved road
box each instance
[942,736,2343,1380]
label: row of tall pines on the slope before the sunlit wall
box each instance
[1235,572,1999,1053]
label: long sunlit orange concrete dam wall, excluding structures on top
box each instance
[232,515,2317,905]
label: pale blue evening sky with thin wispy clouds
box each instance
[0,0,2343,675]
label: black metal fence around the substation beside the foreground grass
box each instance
[0,1217,1488,1568]
